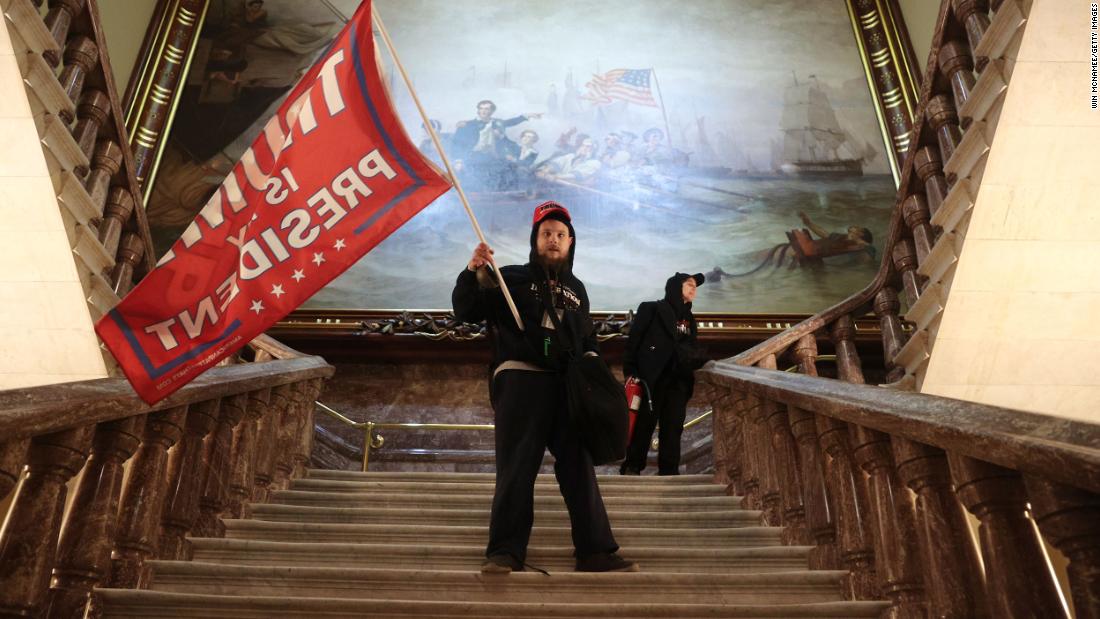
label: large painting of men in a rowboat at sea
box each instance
[150,0,895,313]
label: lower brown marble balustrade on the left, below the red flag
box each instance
[0,336,333,617]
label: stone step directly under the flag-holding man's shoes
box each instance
[144,561,846,604]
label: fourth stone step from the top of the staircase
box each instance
[251,501,762,529]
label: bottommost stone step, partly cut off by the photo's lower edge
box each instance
[96,589,889,619]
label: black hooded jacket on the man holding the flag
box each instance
[451,264,600,371]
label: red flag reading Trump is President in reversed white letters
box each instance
[96,1,450,404]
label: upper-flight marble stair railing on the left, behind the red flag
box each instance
[3,0,155,319]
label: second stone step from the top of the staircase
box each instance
[289,477,726,498]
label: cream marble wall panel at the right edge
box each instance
[921,0,1100,422]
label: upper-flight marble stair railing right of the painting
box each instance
[733,0,1030,388]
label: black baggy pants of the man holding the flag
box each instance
[485,369,618,561]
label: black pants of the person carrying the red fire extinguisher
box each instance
[620,371,694,475]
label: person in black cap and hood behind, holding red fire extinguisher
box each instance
[619,273,706,475]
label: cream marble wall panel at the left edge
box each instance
[0,20,107,389]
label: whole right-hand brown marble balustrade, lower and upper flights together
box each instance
[700,0,1100,618]
